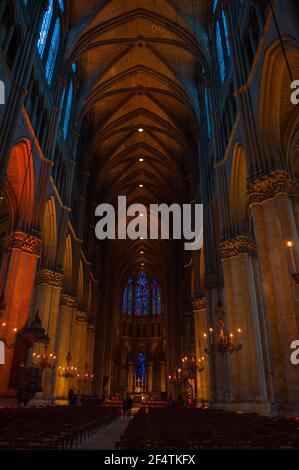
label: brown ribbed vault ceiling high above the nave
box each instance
[68,0,210,284]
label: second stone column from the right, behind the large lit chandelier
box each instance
[220,236,268,411]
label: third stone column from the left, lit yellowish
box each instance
[55,292,78,399]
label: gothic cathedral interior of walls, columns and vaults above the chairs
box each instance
[0,0,299,454]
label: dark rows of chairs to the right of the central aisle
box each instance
[116,408,299,450]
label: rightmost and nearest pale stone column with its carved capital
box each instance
[248,171,299,412]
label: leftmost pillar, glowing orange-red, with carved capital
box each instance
[0,232,41,396]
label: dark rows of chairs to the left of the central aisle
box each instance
[0,405,120,450]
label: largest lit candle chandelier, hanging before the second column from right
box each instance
[204,301,242,356]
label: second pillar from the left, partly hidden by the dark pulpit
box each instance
[33,269,63,400]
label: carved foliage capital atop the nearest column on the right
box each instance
[247,170,298,206]
